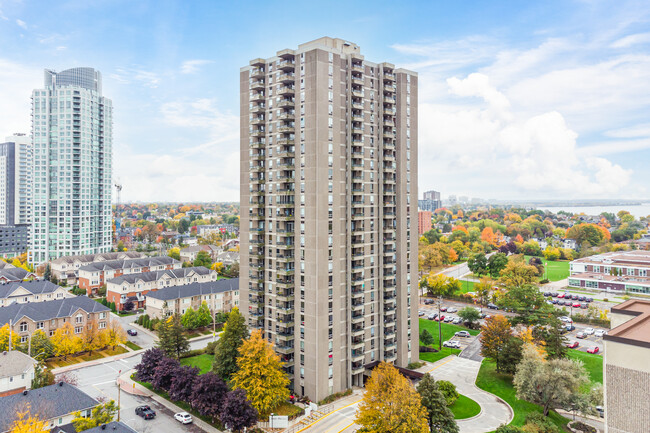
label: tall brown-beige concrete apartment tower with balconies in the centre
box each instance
[240,37,418,400]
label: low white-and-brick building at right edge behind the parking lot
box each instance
[569,251,650,294]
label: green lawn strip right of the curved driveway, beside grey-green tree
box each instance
[476,359,569,431]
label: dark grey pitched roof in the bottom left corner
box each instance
[0,382,99,432]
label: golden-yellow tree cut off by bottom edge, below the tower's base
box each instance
[355,362,429,433]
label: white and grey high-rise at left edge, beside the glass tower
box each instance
[0,134,33,257]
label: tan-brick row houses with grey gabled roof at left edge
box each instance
[0,296,111,343]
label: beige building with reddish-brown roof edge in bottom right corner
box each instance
[603,299,650,433]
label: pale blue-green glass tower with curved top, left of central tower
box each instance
[29,68,113,263]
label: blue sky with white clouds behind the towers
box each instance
[0,0,650,202]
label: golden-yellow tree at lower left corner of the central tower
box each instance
[232,329,289,416]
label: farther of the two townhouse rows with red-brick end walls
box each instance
[78,256,182,296]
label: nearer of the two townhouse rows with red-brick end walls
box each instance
[106,266,218,310]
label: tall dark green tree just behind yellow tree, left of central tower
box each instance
[212,308,248,381]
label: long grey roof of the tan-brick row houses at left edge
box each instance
[0,296,110,326]
